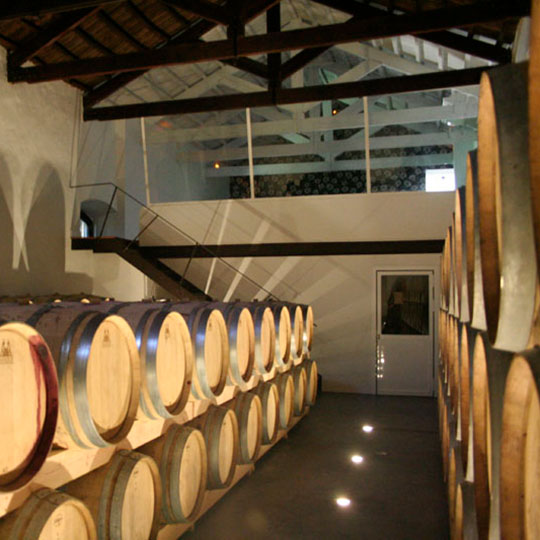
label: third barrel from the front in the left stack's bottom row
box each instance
[138,424,207,523]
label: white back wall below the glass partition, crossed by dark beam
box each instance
[141,193,454,393]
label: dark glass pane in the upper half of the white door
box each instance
[381,275,429,335]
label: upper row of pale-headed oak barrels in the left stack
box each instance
[0,302,313,491]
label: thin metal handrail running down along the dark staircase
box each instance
[69,182,292,301]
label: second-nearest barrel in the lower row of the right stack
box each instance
[472,332,511,540]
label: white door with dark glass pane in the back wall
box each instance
[375,270,434,396]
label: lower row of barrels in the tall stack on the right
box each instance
[438,311,540,540]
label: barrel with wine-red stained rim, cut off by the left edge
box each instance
[0,323,58,491]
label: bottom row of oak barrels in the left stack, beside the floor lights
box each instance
[0,360,317,540]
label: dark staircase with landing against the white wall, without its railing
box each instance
[71,236,212,301]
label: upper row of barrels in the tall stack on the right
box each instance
[441,58,540,352]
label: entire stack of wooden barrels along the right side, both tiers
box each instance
[438,28,540,540]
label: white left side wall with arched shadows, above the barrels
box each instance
[0,50,144,299]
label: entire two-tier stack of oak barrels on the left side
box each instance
[0,301,317,539]
